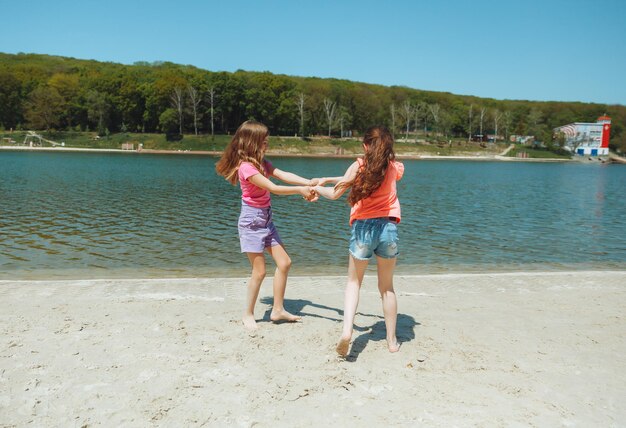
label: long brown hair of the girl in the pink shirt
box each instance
[215,120,270,184]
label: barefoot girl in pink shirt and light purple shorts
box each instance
[215,120,318,330]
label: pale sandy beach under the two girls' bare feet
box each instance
[0,271,626,427]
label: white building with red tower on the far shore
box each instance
[554,116,611,156]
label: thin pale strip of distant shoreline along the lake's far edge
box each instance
[0,146,576,163]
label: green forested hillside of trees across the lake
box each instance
[0,53,626,151]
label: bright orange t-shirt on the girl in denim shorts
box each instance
[350,158,404,224]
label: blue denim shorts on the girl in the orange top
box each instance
[350,217,400,260]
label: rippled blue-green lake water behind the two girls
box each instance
[0,152,626,279]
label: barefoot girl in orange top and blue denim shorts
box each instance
[315,126,404,357]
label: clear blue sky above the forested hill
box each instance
[0,0,626,105]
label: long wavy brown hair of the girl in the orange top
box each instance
[338,126,396,205]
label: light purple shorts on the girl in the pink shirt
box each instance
[237,202,283,253]
